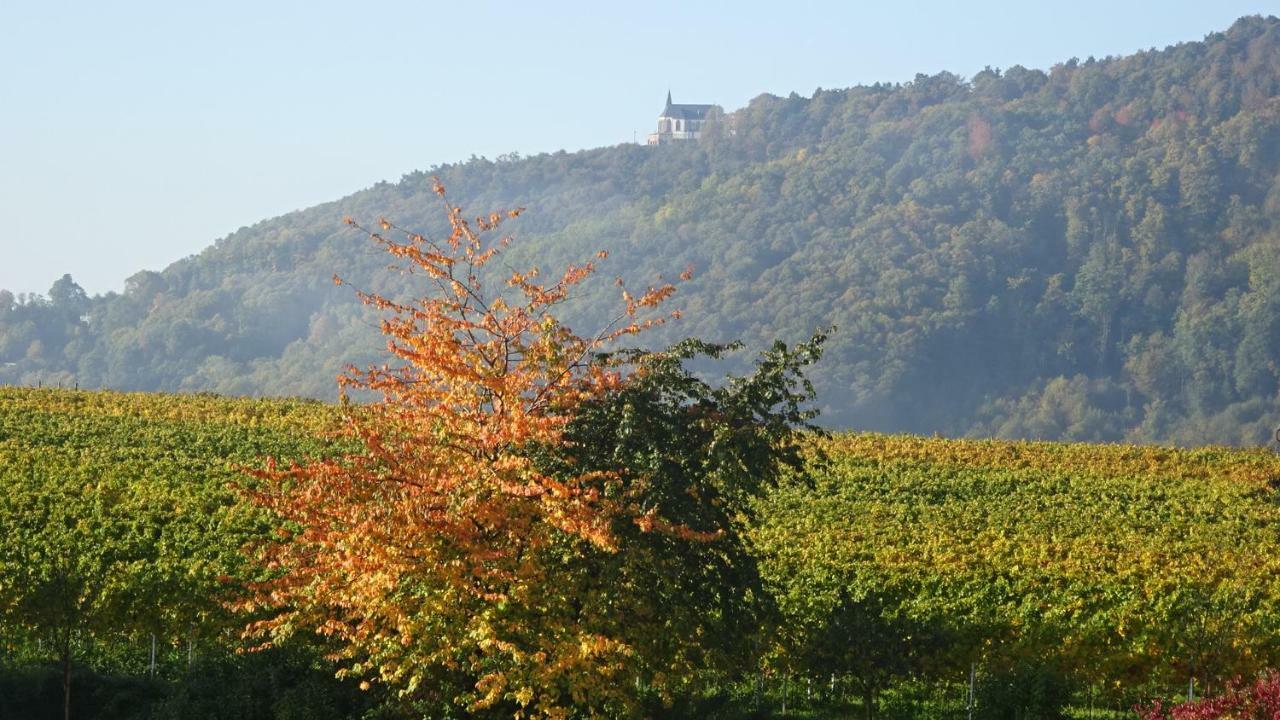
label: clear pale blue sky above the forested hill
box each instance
[0,0,1280,292]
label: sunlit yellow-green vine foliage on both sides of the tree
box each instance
[0,388,1280,687]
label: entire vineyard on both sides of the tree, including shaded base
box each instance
[0,388,1280,717]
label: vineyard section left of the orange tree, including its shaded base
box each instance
[0,388,368,717]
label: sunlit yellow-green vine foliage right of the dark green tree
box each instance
[755,434,1280,687]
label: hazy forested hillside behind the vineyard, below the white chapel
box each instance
[0,18,1280,443]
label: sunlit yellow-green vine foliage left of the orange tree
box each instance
[0,388,338,660]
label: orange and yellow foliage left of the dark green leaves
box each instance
[236,182,687,716]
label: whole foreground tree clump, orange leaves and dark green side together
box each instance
[244,182,820,717]
